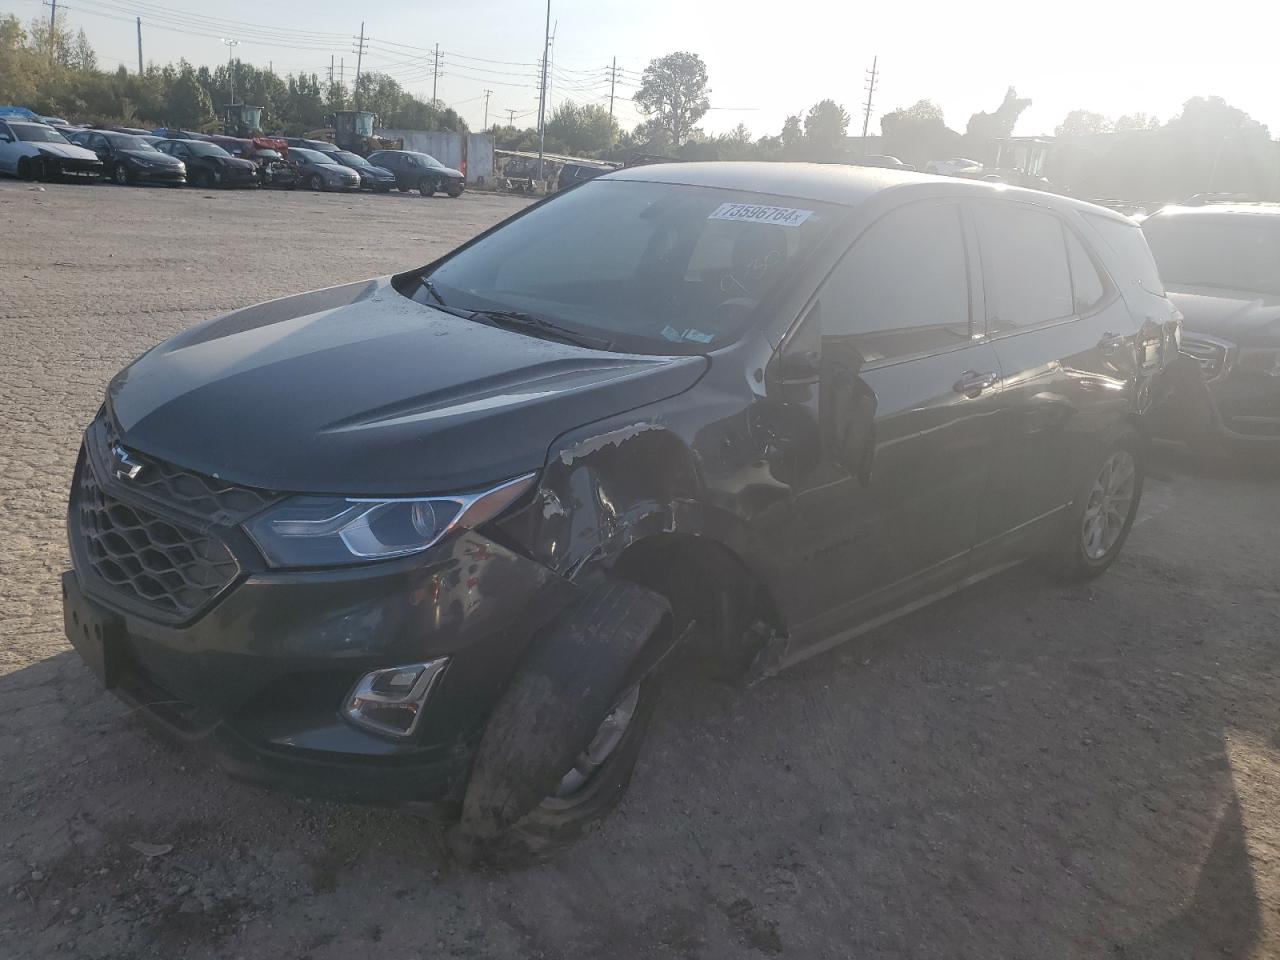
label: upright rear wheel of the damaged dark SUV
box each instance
[1050,425,1147,580]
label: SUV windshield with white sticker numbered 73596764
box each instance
[413,179,838,353]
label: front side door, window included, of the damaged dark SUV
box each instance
[787,201,1001,650]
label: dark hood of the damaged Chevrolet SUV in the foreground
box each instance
[108,278,708,495]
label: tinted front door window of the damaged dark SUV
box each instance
[819,202,970,364]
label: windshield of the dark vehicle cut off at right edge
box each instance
[1142,214,1280,296]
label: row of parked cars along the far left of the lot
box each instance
[0,116,466,197]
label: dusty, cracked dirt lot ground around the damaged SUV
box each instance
[0,180,1280,960]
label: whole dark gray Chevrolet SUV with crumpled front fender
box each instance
[63,164,1178,850]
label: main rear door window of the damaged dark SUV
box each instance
[975,204,1076,334]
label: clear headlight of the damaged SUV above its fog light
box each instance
[244,474,535,567]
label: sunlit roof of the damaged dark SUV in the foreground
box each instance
[594,160,1129,223]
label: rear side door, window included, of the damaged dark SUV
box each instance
[969,200,1138,562]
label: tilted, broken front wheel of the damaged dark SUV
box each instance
[449,581,671,860]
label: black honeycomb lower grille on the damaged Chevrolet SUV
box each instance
[76,456,239,620]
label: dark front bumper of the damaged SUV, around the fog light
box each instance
[63,465,575,804]
